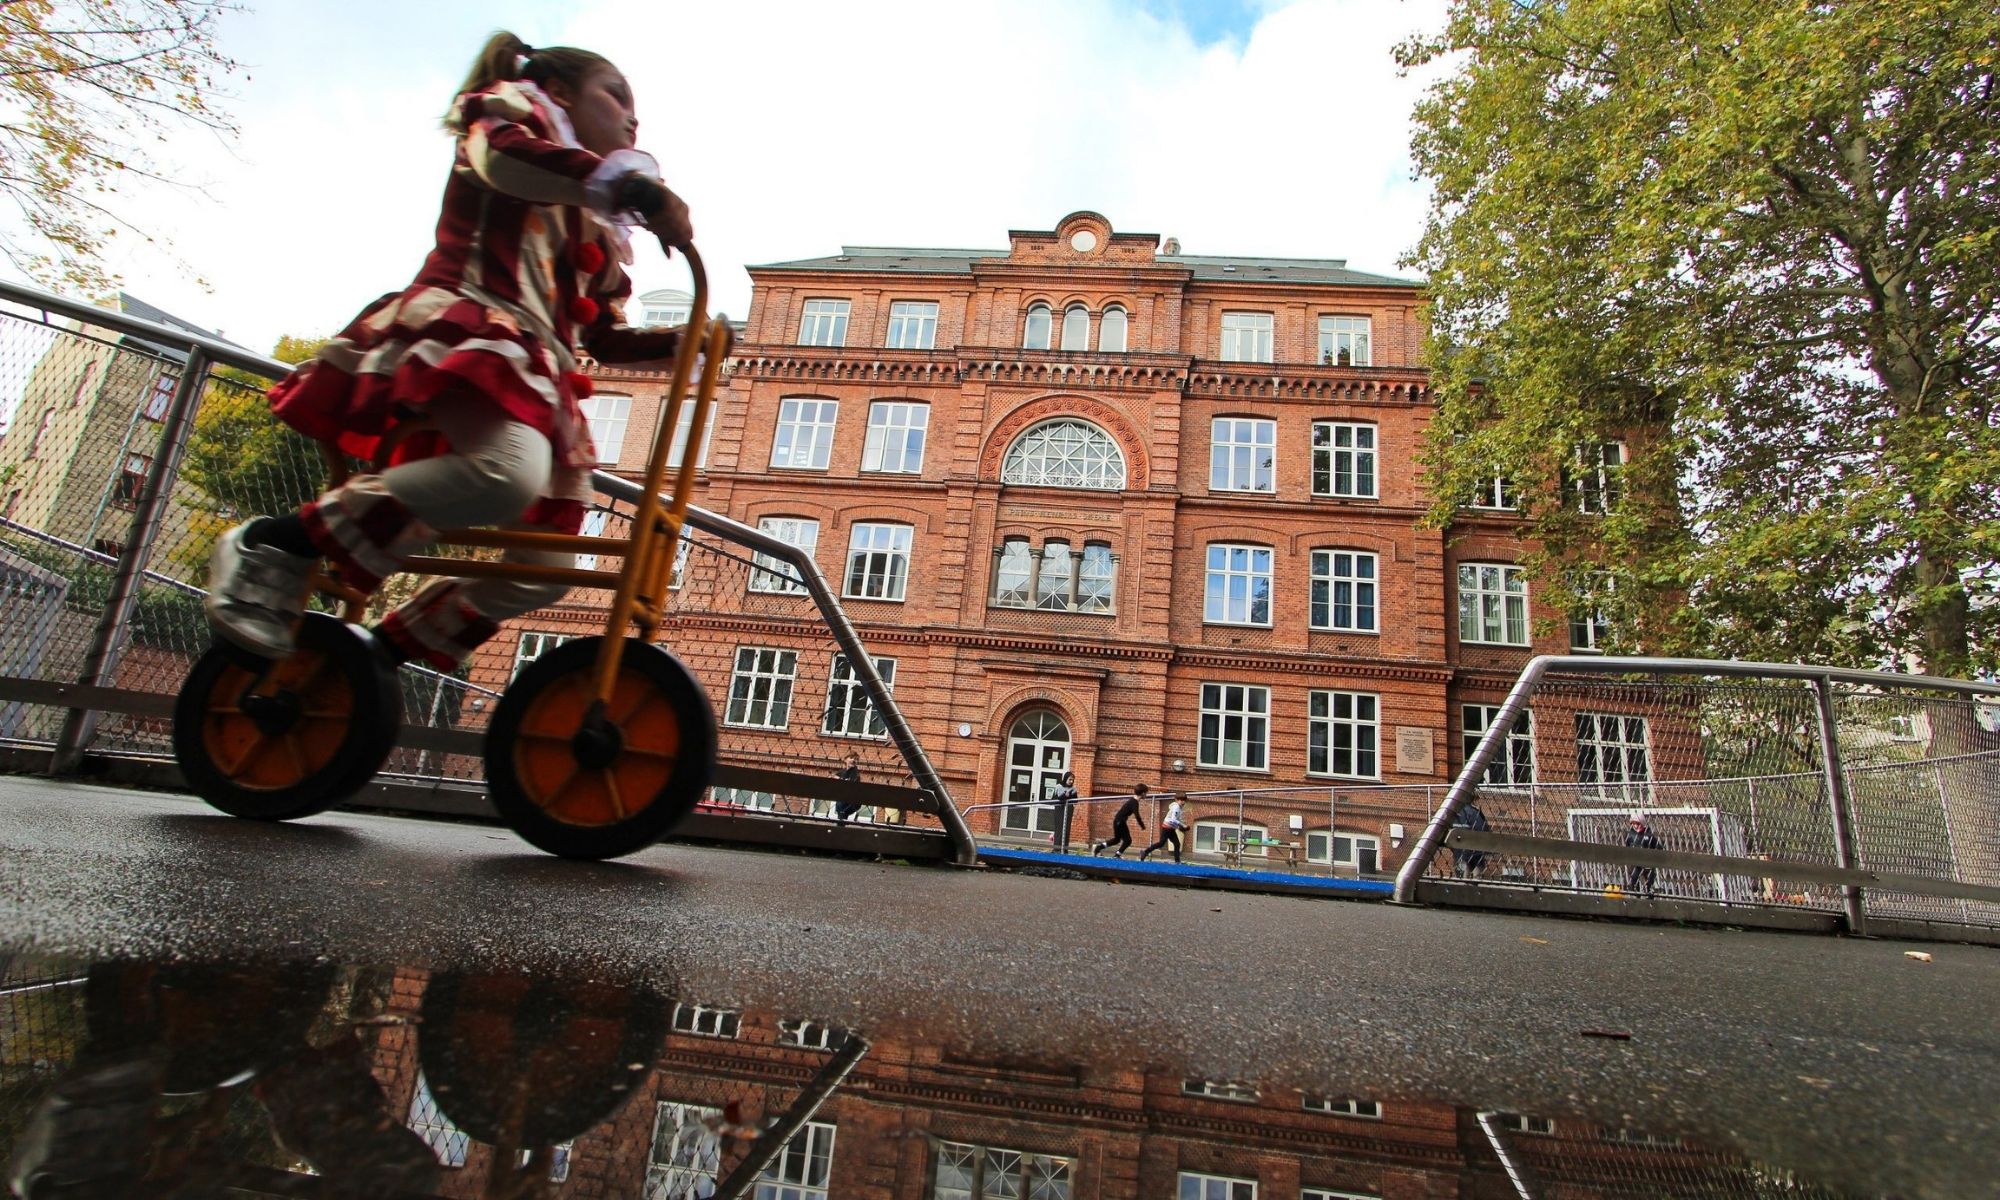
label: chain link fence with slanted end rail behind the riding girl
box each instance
[0,286,970,854]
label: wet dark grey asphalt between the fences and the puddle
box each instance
[0,778,2000,1196]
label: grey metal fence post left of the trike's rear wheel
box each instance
[48,346,208,776]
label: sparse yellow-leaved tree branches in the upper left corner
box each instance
[0,0,236,292]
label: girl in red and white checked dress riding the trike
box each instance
[208,32,694,670]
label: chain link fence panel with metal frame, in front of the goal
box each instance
[1404,660,2000,926]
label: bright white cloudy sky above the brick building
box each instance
[70,0,1442,350]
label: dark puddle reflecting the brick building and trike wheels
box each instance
[0,956,1834,1200]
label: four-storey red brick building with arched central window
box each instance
[500,212,1608,870]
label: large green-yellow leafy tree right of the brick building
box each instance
[1402,0,2000,674]
